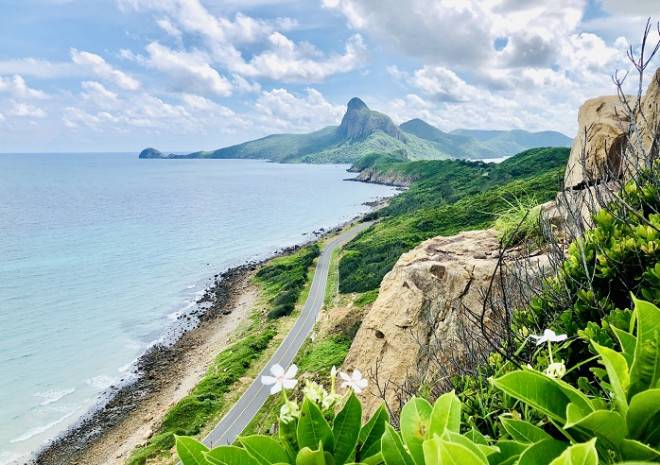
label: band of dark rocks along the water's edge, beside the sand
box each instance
[28,260,260,465]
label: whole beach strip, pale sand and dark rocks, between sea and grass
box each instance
[30,264,258,465]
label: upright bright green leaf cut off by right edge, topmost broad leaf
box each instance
[629,297,660,396]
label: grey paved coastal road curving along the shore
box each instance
[196,222,373,448]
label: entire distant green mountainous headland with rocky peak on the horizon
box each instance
[140,97,573,163]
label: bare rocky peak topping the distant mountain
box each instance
[337,97,407,142]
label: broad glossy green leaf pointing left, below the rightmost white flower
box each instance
[490,368,593,423]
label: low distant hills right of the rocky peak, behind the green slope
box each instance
[451,129,573,157]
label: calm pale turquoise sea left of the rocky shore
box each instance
[0,153,394,465]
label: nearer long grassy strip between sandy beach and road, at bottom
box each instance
[127,323,276,465]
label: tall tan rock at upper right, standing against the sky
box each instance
[564,95,630,189]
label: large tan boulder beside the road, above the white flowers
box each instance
[344,230,548,415]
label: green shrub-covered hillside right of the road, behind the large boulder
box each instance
[339,148,569,292]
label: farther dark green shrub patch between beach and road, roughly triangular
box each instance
[255,243,321,319]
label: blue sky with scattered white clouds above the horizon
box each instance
[0,0,660,153]
